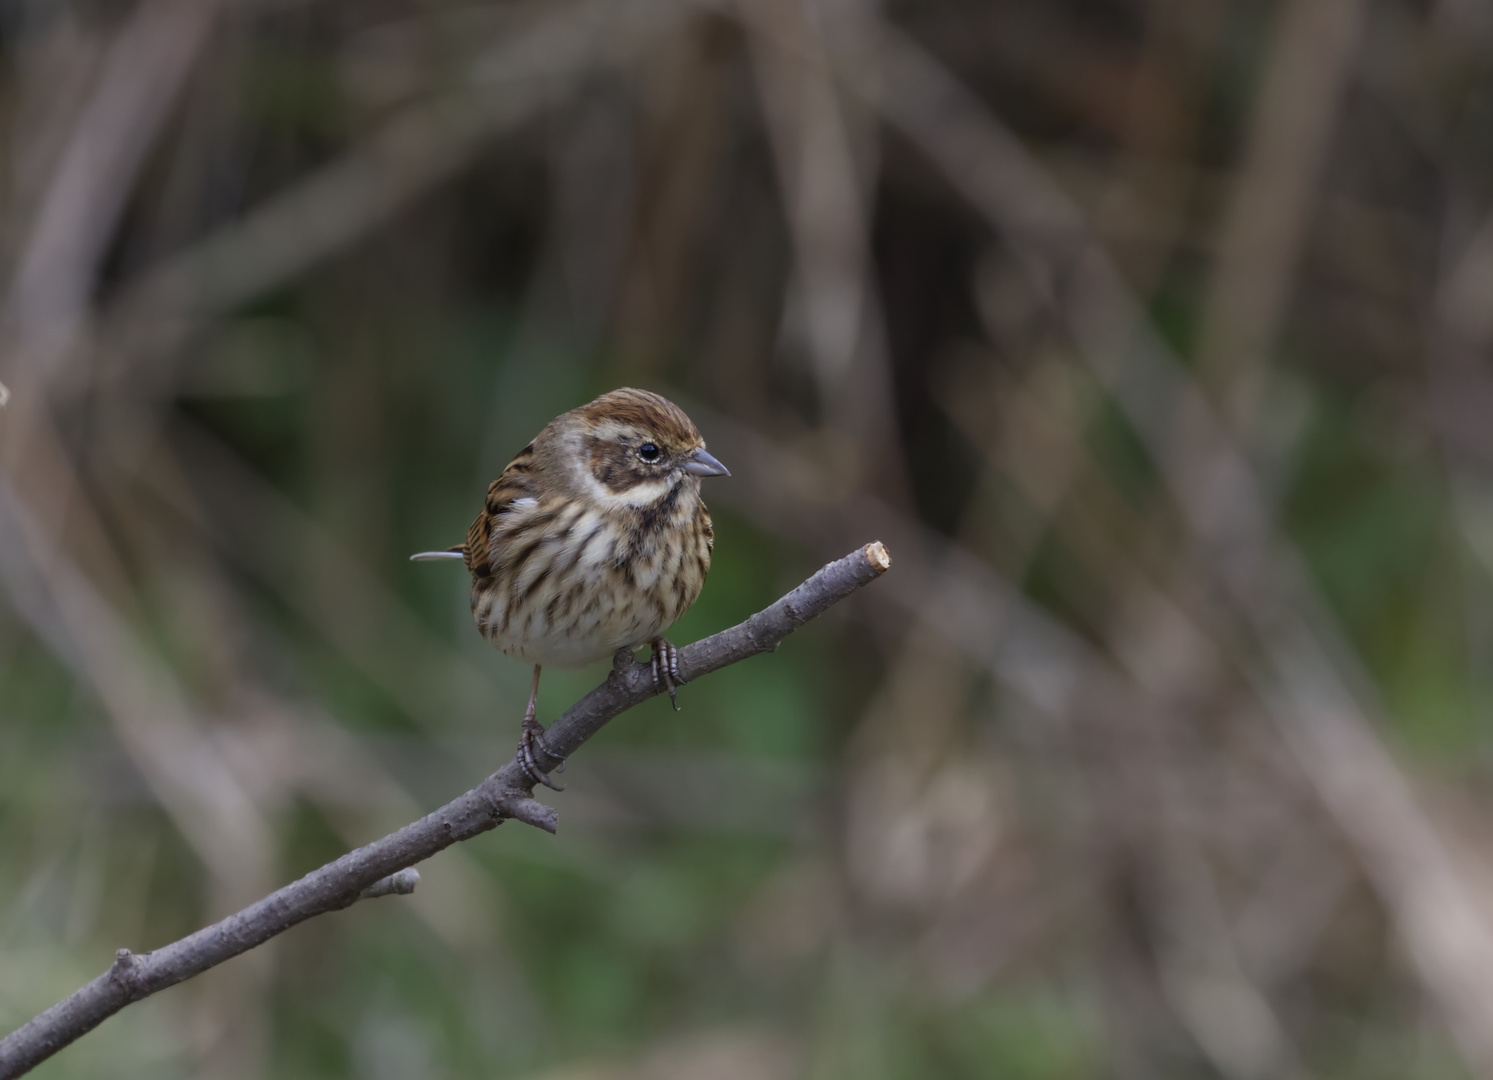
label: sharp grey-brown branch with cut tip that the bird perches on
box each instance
[0,541,891,1080]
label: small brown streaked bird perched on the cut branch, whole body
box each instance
[411,387,730,790]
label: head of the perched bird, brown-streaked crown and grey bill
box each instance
[552,387,730,506]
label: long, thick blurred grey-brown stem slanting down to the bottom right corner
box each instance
[830,23,1493,1071]
